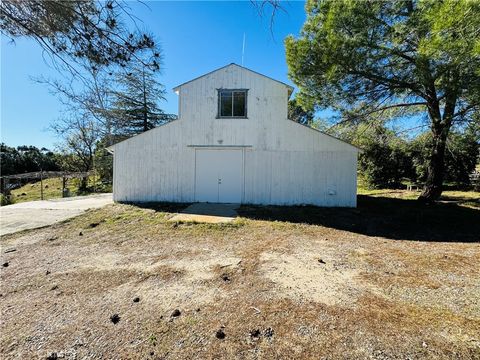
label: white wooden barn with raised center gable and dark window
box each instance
[112,64,359,207]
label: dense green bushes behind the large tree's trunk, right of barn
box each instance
[328,119,480,189]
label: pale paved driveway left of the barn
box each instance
[0,194,113,235]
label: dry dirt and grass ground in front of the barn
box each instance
[0,197,480,359]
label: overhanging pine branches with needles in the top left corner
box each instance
[0,0,160,73]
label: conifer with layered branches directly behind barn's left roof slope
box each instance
[113,65,176,136]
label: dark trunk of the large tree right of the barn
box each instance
[418,124,450,203]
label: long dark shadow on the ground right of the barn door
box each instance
[237,195,480,242]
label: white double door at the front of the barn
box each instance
[195,149,243,203]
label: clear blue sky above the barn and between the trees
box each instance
[1,1,305,148]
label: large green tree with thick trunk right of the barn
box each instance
[286,0,480,202]
